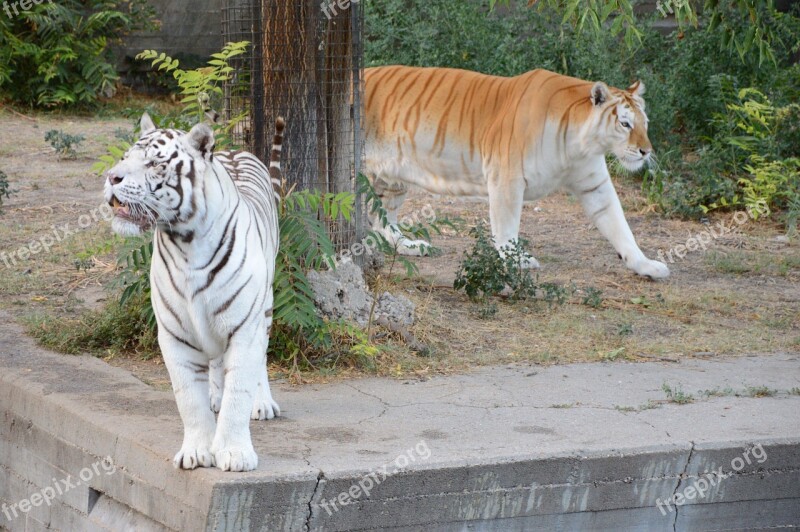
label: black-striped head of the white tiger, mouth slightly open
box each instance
[104,113,214,236]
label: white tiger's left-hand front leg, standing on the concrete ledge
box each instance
[158,336,216,469]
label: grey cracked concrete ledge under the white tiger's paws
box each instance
[0,317,800,531]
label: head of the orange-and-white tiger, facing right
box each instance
[590,81,653,171]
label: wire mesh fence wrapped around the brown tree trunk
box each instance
[223,0,364,256]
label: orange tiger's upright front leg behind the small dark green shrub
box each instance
[489,174,539,269]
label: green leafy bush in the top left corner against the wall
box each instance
[0,0,154,107]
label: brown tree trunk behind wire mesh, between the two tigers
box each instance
[251,0,361,248]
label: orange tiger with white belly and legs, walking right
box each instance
[365,66,669,279]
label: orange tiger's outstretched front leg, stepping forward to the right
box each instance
[573,175,669,279]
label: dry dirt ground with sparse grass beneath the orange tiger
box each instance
[0,111,800,386]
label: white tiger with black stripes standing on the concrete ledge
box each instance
[105,114,284,471]
